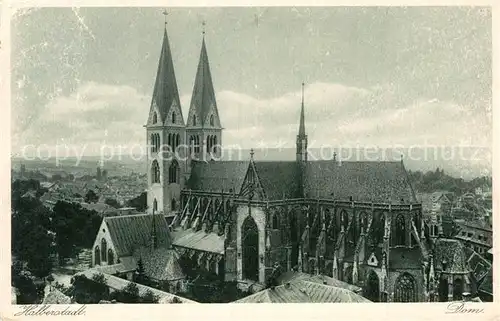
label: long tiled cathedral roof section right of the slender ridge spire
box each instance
[304,160,416,203]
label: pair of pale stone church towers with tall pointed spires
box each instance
[145,23,222,213]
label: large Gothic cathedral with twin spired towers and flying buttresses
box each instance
[93,21,476,302]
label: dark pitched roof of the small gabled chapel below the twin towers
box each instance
[104,214,171,257]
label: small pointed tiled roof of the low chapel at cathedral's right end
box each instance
[434,238,469,273]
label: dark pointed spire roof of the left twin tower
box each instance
[151,29,184,122]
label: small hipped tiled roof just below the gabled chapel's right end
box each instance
[134,247,184,281]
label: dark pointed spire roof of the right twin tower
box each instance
[187,38,221,128]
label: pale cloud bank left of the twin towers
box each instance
[13,82,149,154]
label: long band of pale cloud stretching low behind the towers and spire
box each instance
[14,82,492,165]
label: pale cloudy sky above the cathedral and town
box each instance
[11,7,492,175]
